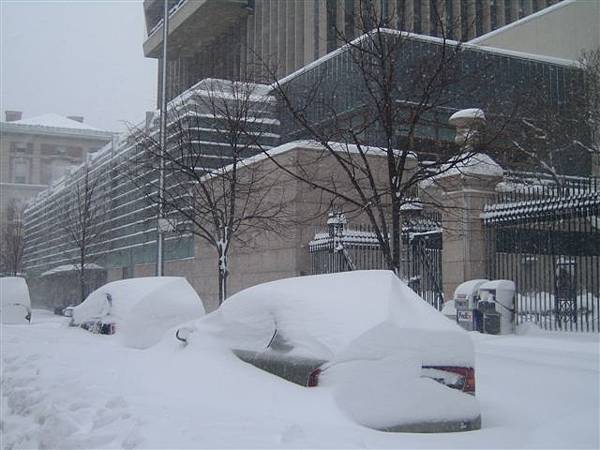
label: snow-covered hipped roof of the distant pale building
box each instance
[2,113,113,138]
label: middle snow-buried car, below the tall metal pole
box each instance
[71,277,205,348]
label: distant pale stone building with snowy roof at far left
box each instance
[0,111,114,241]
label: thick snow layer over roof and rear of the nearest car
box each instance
[218,270,473,364]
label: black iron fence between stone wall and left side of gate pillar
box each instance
[309,213,443,309]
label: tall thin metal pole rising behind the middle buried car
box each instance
[156,0,169,277]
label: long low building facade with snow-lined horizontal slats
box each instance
[23,80,279,306]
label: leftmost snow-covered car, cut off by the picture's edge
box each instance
[0,277,31,325]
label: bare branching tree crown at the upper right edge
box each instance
[502,50,600,186]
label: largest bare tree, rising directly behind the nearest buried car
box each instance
[266,1,486,273]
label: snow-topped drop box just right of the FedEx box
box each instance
[479,280,516,334]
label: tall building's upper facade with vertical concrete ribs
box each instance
[144,0,559,103]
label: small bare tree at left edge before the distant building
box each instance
[0,202,24,275]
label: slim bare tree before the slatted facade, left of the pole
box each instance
[60,163,107,301]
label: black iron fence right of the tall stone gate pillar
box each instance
[482,178,600,332]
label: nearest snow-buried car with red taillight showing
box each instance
[176,271,481,432]
